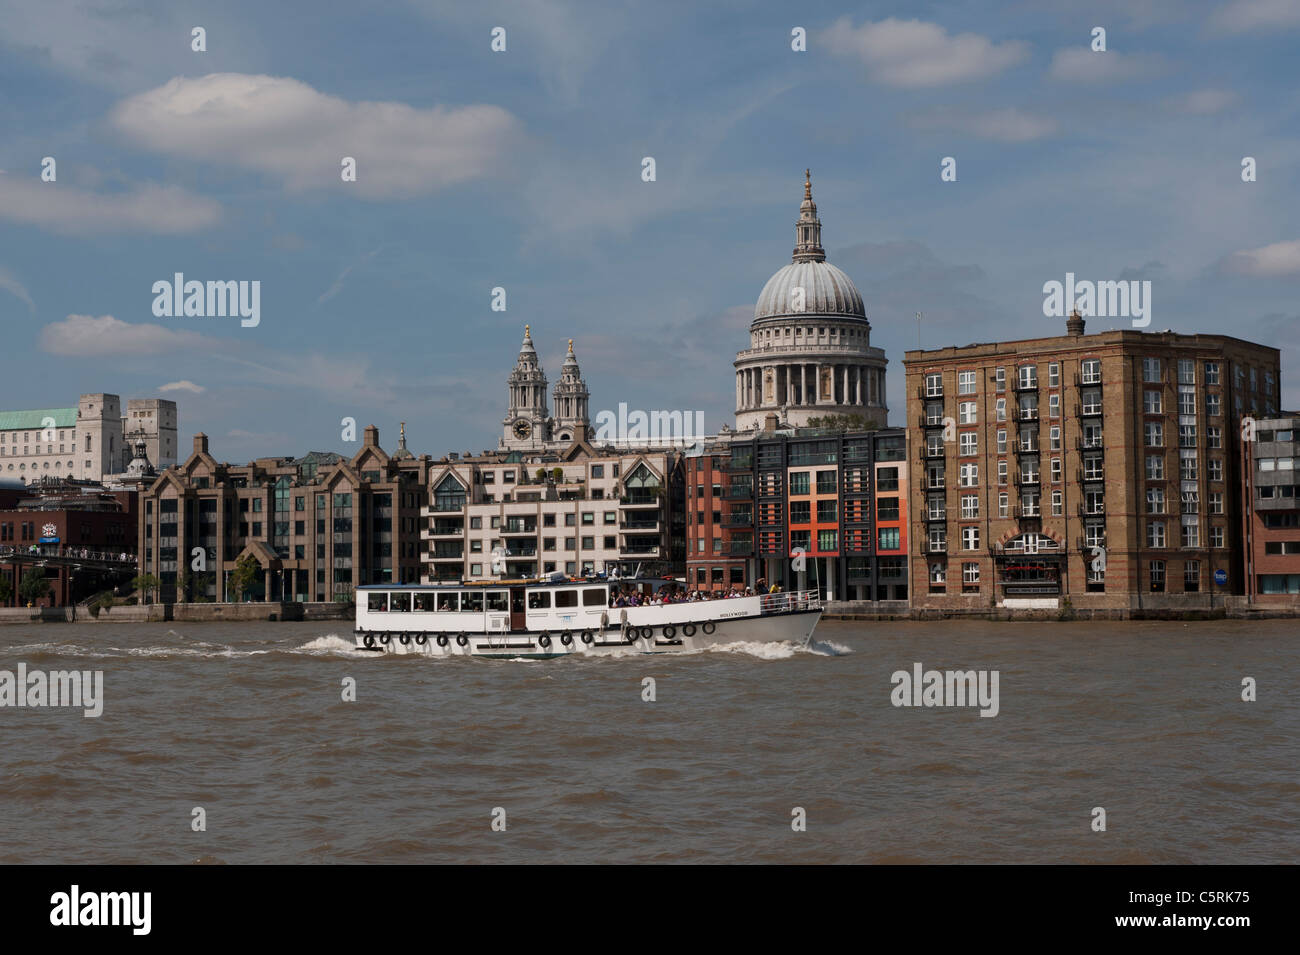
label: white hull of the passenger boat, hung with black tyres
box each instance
[356,609,822,659]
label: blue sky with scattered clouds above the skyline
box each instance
[0,0,1300,461]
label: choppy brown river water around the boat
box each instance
[0,620,1300,863]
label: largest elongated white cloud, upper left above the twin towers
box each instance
[109,73,520,199]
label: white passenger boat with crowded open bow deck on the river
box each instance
[355,578,822,657]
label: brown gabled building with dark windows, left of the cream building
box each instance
[138,425,429,603]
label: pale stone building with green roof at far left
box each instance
[0,394,177,483]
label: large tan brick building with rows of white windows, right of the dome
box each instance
[904,314,1281,611]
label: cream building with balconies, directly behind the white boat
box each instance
[420,439,684,582]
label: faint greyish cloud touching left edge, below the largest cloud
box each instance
[0,175,221,235]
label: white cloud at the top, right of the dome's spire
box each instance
[823,17,1027,87]
